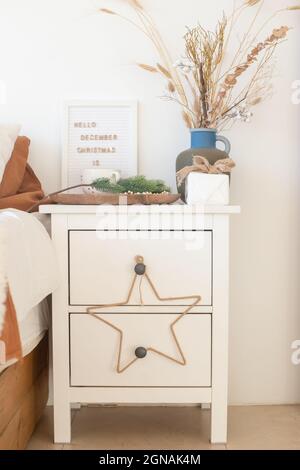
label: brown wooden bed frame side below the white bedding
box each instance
[0,335,49,450]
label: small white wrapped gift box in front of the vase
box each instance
[186,171,229,205]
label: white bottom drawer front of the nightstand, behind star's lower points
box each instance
[70,313,211,387]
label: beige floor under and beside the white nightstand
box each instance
[28,406,300,450]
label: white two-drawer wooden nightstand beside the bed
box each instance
[40,204,240,443]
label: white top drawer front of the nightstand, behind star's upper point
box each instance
[69,230,212,306]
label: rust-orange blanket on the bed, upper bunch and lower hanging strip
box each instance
[0,137,44,362]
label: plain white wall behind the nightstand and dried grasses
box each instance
[0,0,300,403]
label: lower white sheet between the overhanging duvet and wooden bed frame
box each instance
[0,299,49,373]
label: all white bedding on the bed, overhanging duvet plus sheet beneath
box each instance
[0,209,58,372]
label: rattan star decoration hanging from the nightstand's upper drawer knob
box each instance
[87,256,201,374]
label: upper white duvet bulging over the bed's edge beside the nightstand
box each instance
[0,209,58,332]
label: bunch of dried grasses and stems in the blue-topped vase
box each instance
[100,0,300,129]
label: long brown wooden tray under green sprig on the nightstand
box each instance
[51,192,180,206]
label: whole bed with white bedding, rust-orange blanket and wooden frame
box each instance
[0,134,57,450]
